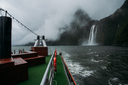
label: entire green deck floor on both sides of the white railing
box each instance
[17,55,69,85]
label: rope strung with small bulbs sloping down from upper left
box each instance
[0,8,38,36]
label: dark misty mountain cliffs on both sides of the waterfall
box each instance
[27,0,128,45]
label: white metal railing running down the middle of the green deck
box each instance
[40,51,55,85]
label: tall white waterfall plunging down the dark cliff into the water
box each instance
[88,25,97,45]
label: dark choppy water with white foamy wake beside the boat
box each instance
[12,46,128,85]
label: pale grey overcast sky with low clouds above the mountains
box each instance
[0,0,125,45]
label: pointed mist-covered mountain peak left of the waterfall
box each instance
[48,9,96,45]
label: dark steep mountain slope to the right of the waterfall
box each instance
[96,0,128,45]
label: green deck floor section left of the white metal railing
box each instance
[18,55,51,85]
